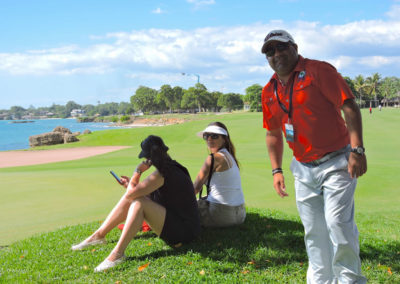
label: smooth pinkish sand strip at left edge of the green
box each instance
[0,146,129,168]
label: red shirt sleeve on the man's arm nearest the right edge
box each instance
[317,62,354,108]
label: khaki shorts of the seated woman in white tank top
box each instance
[197,199,246,227]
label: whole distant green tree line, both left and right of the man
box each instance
[0,73,400,119]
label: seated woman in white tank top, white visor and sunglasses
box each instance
[193,122,246,227]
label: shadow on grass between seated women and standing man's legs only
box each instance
[128,212,307,268]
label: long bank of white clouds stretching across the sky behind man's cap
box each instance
[0,19,400,92]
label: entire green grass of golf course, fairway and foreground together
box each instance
[0,108,400,283]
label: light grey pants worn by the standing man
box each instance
[291,153,366,284]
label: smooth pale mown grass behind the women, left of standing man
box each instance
[0,114,296,245]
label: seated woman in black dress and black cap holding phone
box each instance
[72,135,200,272]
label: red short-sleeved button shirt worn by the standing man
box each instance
[261,56,354,162]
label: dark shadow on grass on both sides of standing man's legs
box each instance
[123,210,400,273]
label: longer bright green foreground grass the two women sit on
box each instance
[0,209,400,283]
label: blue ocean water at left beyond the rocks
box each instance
[0,119,120,151]
